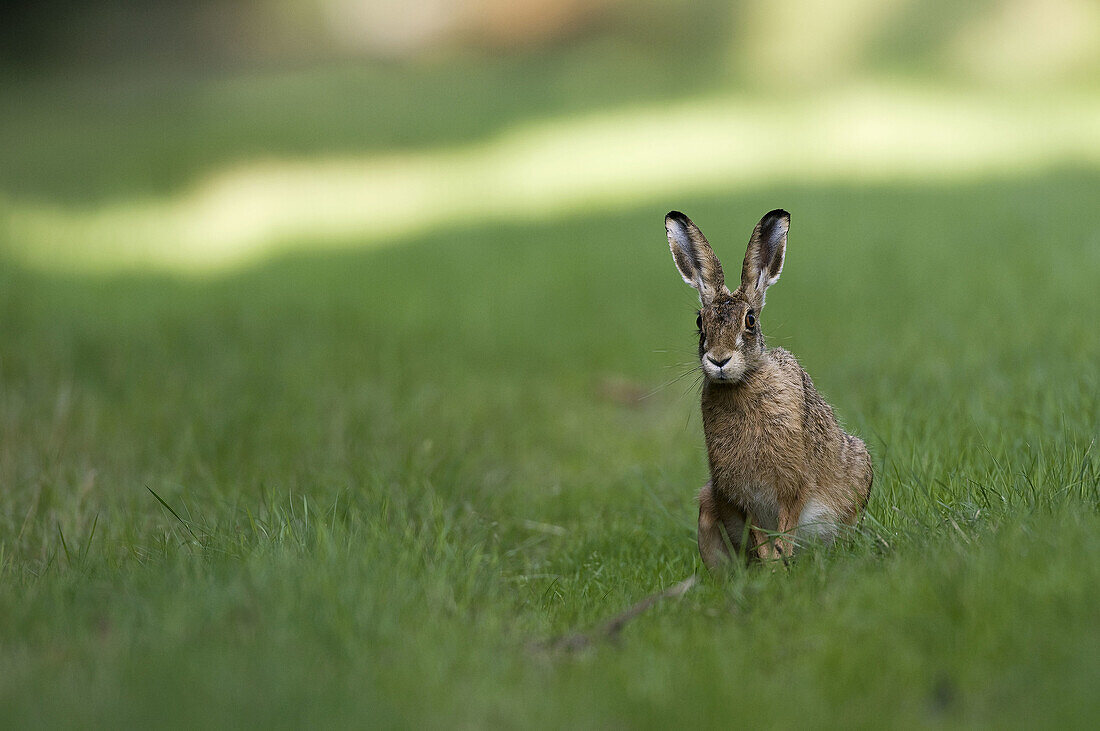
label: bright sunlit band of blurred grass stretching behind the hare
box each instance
[0,88,1100,270]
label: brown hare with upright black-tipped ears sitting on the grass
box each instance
[664,210,873,572]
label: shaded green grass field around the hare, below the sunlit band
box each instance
[0,61,1100,728]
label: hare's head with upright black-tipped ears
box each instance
[664,209,791,383]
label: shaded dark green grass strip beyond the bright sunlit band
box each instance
[0,3,729,202]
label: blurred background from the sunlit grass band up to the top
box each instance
[0,0,1100,270]
